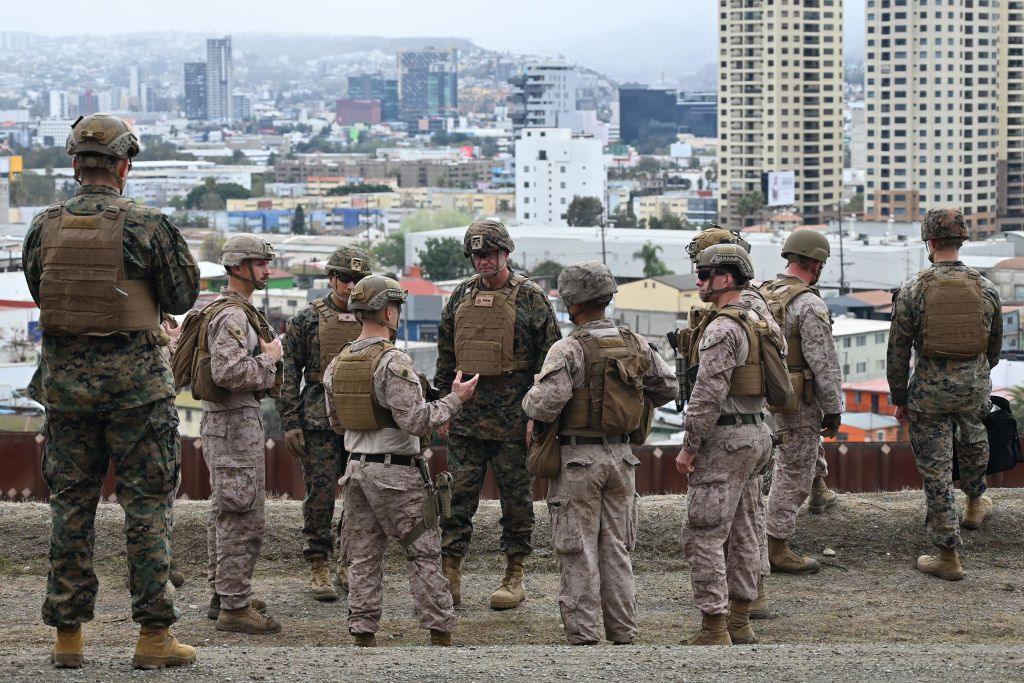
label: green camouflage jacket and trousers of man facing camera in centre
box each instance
[434,278,561,557]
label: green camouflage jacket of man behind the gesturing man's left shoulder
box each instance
[275,294,345,431]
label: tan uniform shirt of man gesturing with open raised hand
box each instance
[324,337,462,455]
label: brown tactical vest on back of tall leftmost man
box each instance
[39,199,160,336]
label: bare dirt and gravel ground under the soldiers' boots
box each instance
[0,489,1024,681]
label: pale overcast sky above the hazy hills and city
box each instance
[8,0,864,81]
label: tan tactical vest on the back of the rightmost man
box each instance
[918,268,998,360]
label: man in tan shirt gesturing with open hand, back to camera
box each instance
[324,275,478,647]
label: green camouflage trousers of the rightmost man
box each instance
[910,411,988,548]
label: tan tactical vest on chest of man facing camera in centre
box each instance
[455,273,531,377]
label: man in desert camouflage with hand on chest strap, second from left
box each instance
[200,233,283,634]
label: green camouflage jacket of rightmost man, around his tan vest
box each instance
[887,261,1002,413]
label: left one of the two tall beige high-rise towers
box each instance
[718,0,843,225]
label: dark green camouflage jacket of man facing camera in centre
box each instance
[434,270,562,440]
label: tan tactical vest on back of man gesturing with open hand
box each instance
[331,340,398,431]
